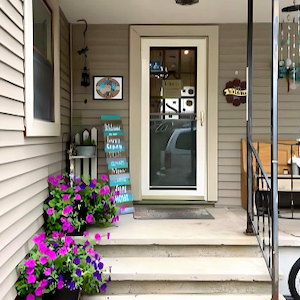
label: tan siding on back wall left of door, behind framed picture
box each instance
[73,25,129,174]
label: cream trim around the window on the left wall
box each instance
[24,0,61,137]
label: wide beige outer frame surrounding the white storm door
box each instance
[129,25,219,202]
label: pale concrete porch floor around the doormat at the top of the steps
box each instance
[89,206,300,246]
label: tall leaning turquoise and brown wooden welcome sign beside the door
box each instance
[101,115,133,211]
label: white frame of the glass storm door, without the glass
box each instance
[140,37,207,200]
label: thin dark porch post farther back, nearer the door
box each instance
[246,0,253,234]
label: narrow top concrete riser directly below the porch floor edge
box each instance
[96,244,262,257]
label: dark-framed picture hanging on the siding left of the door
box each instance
[93,76,123,100]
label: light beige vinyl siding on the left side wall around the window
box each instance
[0,0,70,300]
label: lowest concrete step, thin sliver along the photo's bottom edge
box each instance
[83,294,284,300]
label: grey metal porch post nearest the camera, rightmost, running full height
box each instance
[271,0,279,300]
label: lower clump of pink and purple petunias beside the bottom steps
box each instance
[15,231,110,300]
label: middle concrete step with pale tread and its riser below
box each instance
[103,257,270,295]
